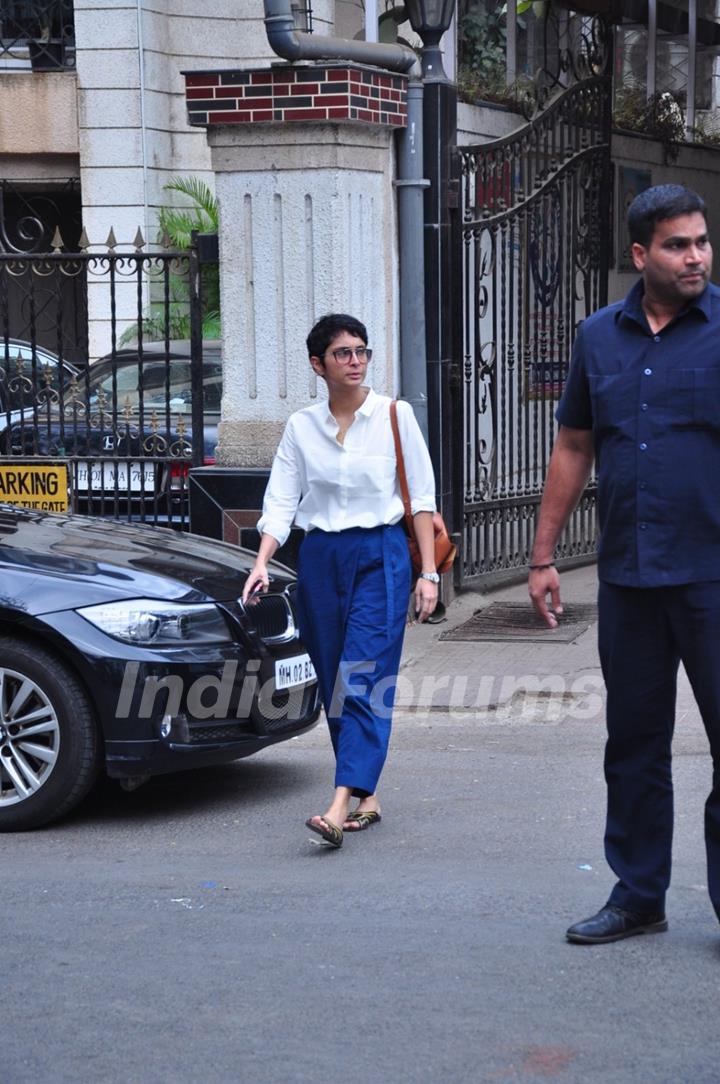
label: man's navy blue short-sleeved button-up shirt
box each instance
[556,280,720,588]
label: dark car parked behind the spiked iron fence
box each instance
[12,340,222,526]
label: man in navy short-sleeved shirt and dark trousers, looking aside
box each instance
[529,184,720,944]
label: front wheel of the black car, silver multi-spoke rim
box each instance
[0,636,100,831]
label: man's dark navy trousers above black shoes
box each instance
[599,582,720,918]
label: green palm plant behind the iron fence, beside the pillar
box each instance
[120,177,220,346]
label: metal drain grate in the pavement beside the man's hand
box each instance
[440,602,597,644]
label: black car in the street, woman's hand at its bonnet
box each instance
[0,504,319,831]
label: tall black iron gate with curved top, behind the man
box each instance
[453,22,610,584]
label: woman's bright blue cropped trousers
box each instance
[297,524,410,798]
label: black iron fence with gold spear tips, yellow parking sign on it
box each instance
[0,235,217,528]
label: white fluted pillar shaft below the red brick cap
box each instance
[210,125,397,466]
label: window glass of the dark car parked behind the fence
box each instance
[89,358,222,414]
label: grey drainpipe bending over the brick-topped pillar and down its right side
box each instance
[263,0,429,440]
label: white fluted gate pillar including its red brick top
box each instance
[185,64,406,468]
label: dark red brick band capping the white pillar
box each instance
[184,64,408,127]
